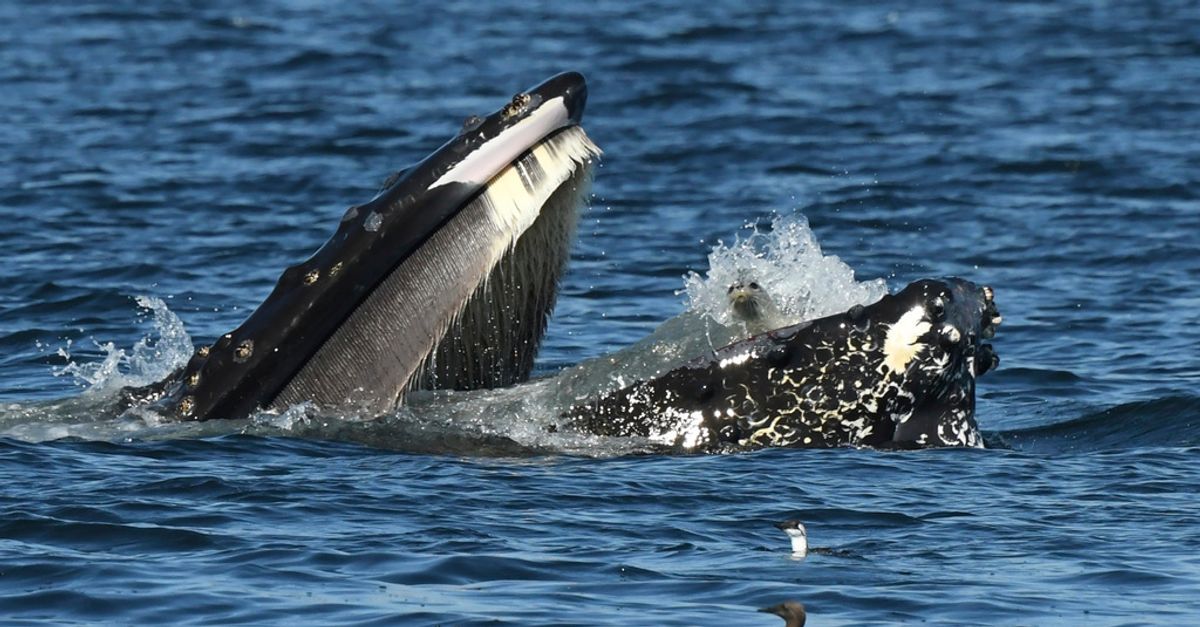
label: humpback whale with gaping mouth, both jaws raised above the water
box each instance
[124,72,1001,452]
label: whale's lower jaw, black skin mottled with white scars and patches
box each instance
[563,279,1000,452]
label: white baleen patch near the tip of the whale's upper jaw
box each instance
[478,126,601,240]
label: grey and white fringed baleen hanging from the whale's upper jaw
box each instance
[269,126,599,414]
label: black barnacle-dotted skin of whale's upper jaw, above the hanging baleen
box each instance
[125,72,587,420]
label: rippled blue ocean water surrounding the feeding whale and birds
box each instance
[0,0,1200,626]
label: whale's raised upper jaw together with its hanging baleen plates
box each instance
[166,73,600,419]
